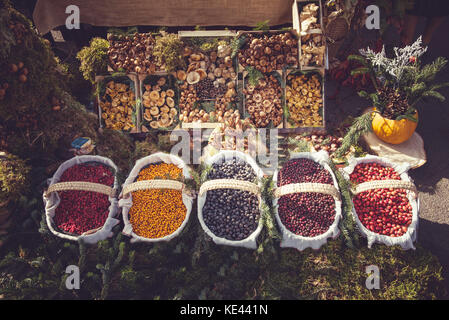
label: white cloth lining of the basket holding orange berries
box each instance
[118,152,193,242]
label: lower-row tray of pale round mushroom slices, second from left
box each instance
[140,74,179,130]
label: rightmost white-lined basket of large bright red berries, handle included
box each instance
[342,155,419,250]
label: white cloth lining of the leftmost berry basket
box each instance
[43,155,120,244]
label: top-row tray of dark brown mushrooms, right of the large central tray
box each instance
[237,29,300,73]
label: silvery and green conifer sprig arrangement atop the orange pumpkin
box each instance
[337,37,449,155]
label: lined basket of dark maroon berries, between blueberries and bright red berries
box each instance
[273,151,342,251]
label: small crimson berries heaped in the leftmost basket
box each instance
[53,163,114,235]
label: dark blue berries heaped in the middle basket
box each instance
[203,159,260,240]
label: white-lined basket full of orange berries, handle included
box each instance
[119,152,193,242]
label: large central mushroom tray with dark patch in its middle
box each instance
[177,31,238,128]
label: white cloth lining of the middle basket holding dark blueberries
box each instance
[198,150,263,249]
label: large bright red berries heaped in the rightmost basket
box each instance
[350,162,412,237]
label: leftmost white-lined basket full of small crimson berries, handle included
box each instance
[43,156,120,243]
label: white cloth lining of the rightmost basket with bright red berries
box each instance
[342,155,419,250]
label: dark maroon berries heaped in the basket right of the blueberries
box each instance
[278,158,336,237]
